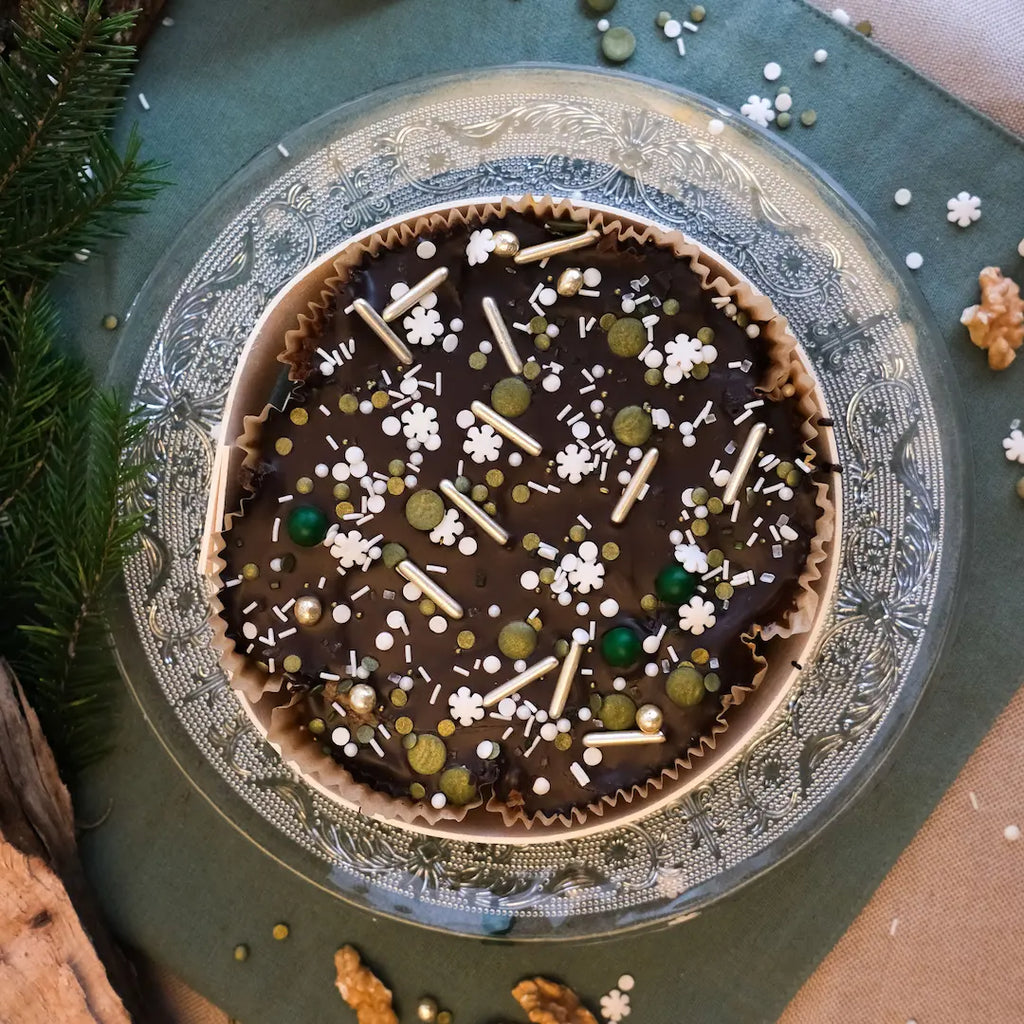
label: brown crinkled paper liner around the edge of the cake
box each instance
[205,196,836,829]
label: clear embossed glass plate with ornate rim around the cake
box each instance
[108,67,964,939]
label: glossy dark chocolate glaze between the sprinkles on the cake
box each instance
[222,215,819,813]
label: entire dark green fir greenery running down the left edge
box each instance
[0,0,159,774]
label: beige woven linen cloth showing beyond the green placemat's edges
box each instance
[155,0,1024,1024]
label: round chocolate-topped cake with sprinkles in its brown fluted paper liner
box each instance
[214,199,831,825]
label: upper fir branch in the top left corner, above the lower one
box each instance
[0,0,163,281]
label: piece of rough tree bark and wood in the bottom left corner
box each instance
[0,658,148,1024]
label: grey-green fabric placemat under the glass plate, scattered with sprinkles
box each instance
[61,0,1024,1024]
